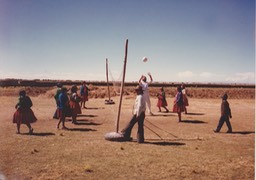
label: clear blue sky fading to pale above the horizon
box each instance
[0,0,255,83]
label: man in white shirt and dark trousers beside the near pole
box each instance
[121,85,146,143]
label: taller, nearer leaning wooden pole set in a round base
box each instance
[116,39,128,132]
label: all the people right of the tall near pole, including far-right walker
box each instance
[121,73,232,143]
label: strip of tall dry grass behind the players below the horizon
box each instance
[0,84,255,99]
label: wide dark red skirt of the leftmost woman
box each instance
[12,108,37,124]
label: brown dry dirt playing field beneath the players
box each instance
[0,89,255,180]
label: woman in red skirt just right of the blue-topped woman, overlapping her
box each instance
[69,86,81,124]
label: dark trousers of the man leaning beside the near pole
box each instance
[121,112,145,143]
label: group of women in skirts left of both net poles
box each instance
[13,82,89,134]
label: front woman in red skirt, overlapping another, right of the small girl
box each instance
[173,86,184,122]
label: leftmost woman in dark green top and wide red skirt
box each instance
[13,90,37,134]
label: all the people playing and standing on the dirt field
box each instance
[13,73,232,143]
